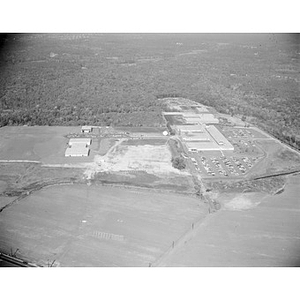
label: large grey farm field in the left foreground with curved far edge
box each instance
[0,185,207,266]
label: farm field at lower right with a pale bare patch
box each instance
[160,175,300,267]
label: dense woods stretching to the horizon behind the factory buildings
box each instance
[0,34,300,148]
